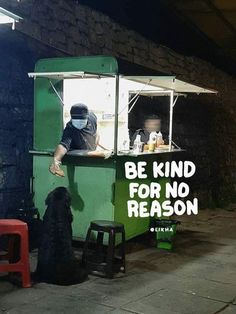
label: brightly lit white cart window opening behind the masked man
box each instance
[63,77,119,150]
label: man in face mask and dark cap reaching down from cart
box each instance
[49,103,98,176]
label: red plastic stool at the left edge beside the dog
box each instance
[0,219,31,288]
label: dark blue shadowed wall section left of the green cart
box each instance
[0,26,64,218]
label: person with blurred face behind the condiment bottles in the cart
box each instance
[130,115,164,146]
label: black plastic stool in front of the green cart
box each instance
[82,220,125,278]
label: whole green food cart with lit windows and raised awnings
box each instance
[29,56,218,239]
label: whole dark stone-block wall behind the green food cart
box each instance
[0,0,236,213]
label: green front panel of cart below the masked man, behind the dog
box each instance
[34,155,115,240]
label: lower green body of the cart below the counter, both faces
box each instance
[34,154,170,240]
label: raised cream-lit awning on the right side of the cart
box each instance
[123,76,217,94]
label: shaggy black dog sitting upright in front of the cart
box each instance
[35,187,88,285]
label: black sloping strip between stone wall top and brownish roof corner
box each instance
[80,0,236,76]
